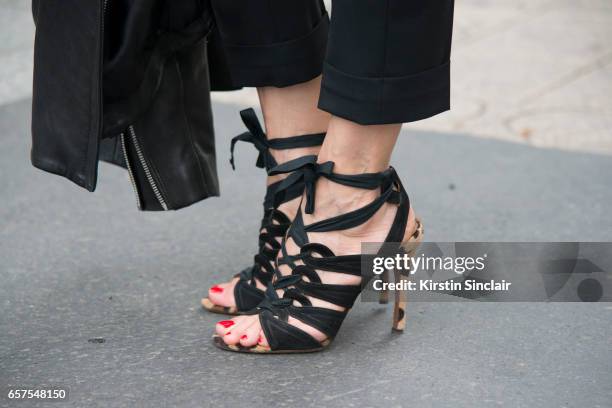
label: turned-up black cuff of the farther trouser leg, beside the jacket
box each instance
[224,14,329,87]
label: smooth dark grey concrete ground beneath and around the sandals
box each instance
[0,101,612,408]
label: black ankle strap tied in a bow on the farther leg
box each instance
[230,108,325,170]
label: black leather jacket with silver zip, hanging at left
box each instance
[31,0,237,210]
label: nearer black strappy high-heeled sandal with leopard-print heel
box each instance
[213,156,423,354]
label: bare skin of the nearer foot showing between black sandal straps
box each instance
[215,163,417,351]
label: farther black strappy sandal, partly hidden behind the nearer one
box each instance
[201,108,325,315]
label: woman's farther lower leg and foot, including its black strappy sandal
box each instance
[202,76,331,313]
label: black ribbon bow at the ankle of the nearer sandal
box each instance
[268,155,334,214]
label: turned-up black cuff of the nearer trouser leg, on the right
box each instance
[319,61,450,125]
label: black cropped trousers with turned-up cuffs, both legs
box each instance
[211,0,454,125]
